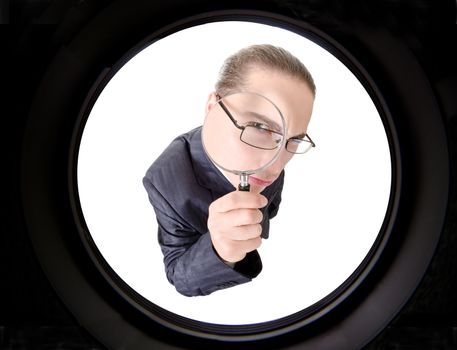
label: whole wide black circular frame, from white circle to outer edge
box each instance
[18,1,449,349]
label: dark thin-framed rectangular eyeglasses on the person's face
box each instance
[217,95,316,154]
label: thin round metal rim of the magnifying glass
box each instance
[202,90,287,175]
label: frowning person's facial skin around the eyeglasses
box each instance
[204,67,314,193]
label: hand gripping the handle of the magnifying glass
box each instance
[208,191,268,263]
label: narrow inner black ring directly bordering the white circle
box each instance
[69,12,401,341]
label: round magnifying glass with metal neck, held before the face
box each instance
[202,92,286,191]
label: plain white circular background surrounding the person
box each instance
[77,22,391,324]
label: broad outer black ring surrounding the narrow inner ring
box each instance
[18,1,449,349]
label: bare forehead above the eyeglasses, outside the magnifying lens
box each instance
[244,67,314,135]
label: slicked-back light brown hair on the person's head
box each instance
[215,44,316,96]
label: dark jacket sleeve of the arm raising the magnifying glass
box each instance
[143,177,262,296]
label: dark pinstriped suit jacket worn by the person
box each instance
[143,127,284,296]
